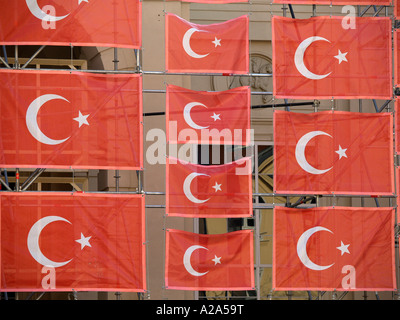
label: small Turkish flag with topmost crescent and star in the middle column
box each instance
[165,13,249,74]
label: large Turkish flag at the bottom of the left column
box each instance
[0,192,146,292]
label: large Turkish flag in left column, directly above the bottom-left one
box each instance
[0,70,143,170]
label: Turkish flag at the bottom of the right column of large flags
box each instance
[272,207,396,291]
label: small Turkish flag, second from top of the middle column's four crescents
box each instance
[166,85,251,145]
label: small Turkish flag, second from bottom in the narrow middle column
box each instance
[165,157,253,218]
